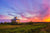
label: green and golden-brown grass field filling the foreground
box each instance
[0,23,48,33]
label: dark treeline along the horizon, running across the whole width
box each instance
[0,21,50,25]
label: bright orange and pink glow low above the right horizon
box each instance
[22,16,50,22]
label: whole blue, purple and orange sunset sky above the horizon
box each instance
[0,0,50,22]
